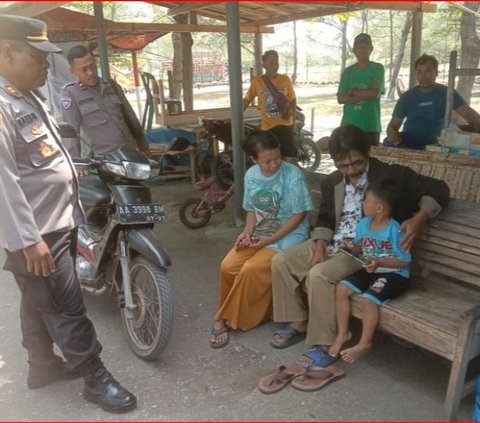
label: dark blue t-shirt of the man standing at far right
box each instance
[393,84,465,142]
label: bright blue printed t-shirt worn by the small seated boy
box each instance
[355,216,412,278]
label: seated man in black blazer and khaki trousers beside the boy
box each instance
[270,124,449,367]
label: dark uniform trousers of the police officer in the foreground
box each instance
[5,229,102,370]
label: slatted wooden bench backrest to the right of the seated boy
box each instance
[412,199,480,288]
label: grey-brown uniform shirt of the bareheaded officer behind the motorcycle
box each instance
[60,78,137,157]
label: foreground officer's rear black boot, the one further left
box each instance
[27,351,81,389]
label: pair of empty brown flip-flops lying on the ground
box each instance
[258,364,345,394]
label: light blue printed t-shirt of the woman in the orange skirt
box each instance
[243,162,313,251]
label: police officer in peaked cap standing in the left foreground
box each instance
[0,14,137,412]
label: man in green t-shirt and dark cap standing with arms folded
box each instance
[337,33,385,145]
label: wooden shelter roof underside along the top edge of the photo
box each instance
[0,1,436,50]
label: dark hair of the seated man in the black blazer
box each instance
[328,123,370,161]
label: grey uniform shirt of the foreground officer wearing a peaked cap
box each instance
[0,77,83,251]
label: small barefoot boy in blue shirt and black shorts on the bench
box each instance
[329,179,411,363]
